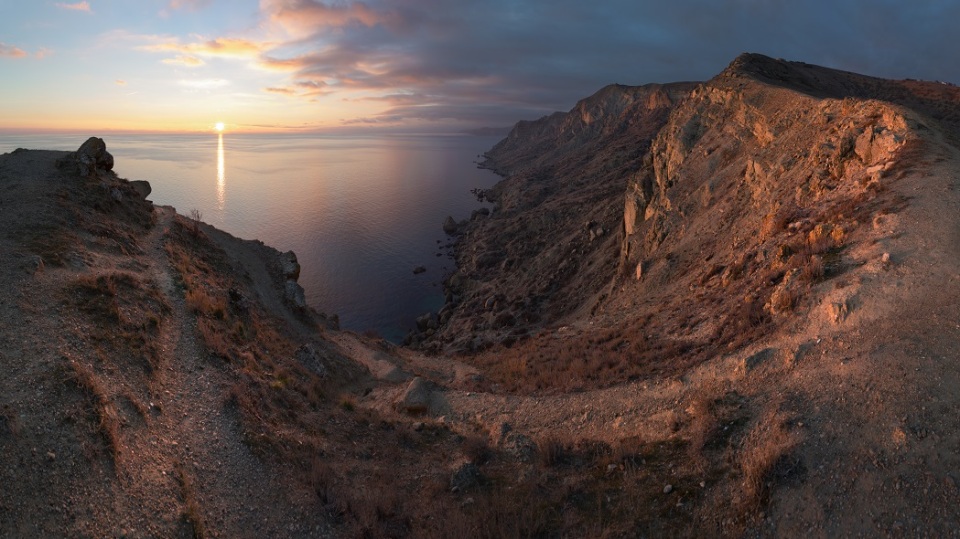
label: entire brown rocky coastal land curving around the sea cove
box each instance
[9,54,960,537]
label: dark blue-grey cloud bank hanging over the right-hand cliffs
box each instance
[261,0,960,125]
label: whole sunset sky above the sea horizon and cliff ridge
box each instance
[0,0,960,132]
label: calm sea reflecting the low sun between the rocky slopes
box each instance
[0,134,499,341]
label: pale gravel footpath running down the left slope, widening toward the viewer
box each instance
[112,208,326,537]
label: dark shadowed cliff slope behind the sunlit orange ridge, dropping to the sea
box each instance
[420,79,694,350]
